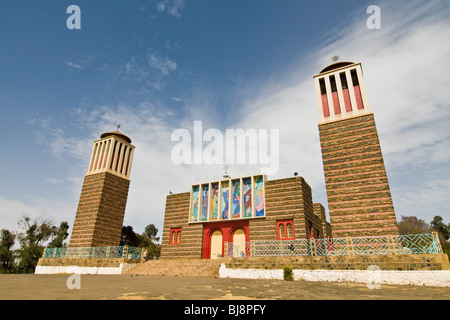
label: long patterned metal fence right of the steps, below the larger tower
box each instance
[225,232,442,257]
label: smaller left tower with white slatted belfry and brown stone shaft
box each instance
[70,131,134,247]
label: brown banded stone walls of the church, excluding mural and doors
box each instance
[161,177,331,259]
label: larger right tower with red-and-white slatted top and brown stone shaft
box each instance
[314,62,398,237]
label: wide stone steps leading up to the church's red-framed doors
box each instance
[124,259,223,277]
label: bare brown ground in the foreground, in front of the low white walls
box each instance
[0,274,450,301]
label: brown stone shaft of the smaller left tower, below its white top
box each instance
[70,172,130,247]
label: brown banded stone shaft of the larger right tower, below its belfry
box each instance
[319,114,398,237]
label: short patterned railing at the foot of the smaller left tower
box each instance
[42,246,142,259]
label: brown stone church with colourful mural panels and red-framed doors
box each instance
[161,175,331,259]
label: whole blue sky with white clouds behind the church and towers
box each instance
[0,0,450,240]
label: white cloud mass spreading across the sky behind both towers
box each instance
[29,1,450,238]
